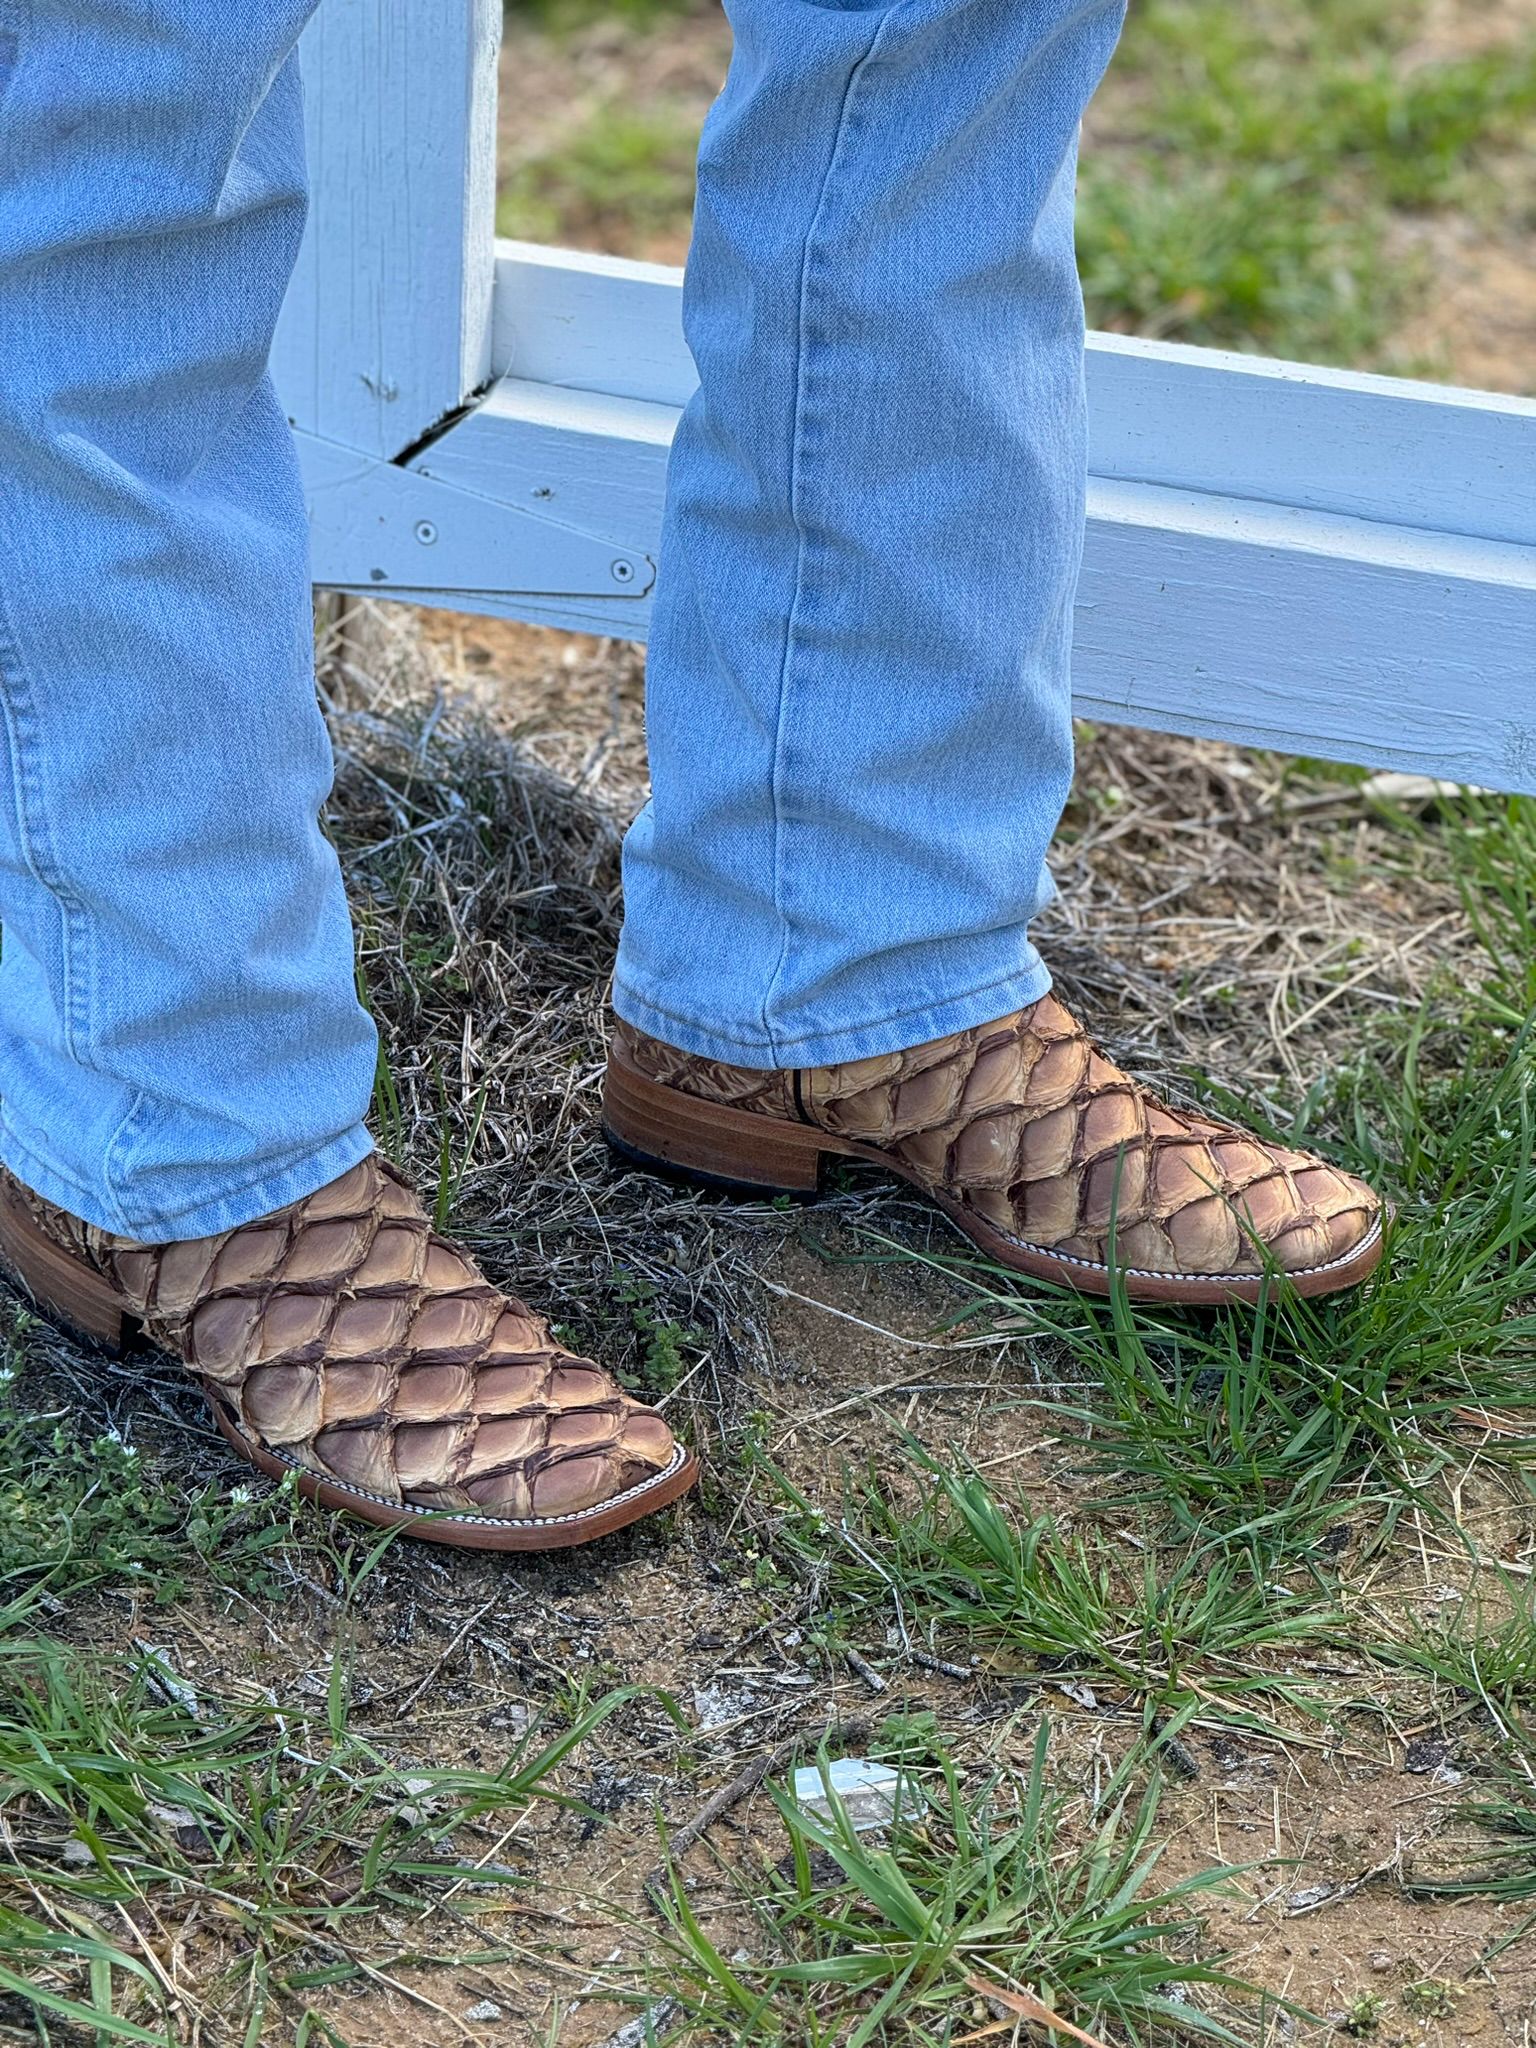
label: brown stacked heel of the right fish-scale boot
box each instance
[602,1053,844,1200]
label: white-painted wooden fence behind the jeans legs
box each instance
[274,0,1536,793]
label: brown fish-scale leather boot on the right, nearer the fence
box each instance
[604,995,1382,1303]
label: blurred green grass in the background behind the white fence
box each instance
[500,0,1536,373]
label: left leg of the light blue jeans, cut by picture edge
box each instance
[0,0,375,1239]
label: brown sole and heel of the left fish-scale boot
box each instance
[0,1186,698,1550]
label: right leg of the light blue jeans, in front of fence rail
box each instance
[614,0,1124,1067]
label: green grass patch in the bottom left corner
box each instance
[0,1575,663,2048]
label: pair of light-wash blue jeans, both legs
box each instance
[0,0,1120,1239]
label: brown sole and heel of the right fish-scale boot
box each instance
[602,1047,1384,1307]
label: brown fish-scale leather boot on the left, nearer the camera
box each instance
[0,1153,698,1550]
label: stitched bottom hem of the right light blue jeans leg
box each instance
[612,946,1051,1069]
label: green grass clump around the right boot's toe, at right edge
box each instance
[946,995,1536,1544]
